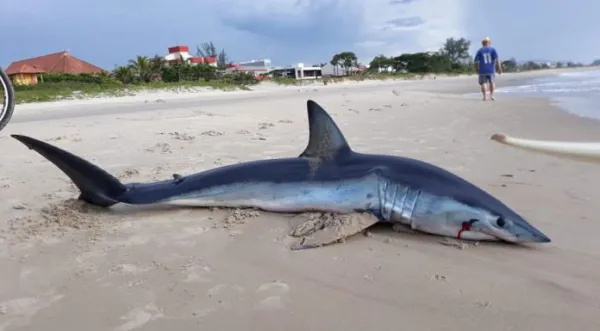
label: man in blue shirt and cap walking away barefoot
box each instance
[475,37,502,101]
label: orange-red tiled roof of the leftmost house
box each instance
[6,52,104,75]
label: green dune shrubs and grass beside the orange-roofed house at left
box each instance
[15,43,258,103]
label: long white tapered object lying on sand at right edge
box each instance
[492,134,600,163]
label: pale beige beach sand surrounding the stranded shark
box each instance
[0,75,600,331]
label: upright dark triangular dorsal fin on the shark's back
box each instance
[300,100,352,160]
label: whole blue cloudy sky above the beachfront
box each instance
[0,0,600,70]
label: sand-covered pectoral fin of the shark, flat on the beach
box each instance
[290,213,379,250]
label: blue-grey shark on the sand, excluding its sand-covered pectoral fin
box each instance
[12,100,550,248]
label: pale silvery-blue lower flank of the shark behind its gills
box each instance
[161,176,379,213]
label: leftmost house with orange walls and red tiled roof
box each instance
[5,51,104,85]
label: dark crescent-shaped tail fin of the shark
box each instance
[12,134,127,207]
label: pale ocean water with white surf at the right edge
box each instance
[496,69,600,120]
